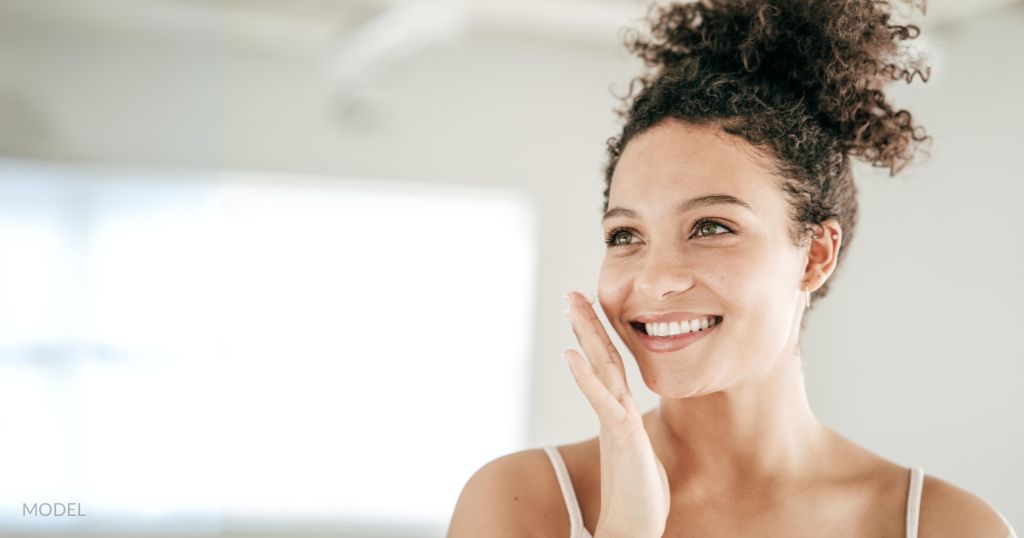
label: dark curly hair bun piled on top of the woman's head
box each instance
[627,0,931,174]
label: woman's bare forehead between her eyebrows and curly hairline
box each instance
[608,121,781,214]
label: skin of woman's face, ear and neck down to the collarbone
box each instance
[598,116,842,500]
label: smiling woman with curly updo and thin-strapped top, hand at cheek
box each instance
[449,0,1016,538]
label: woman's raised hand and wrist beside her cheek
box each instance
[562,292,670,538]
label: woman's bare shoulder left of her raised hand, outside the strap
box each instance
[447,448,569,538]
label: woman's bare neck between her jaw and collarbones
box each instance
[644,354,828,500]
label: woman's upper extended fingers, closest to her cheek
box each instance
[567,292,629,401]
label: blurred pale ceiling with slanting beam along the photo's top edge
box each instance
[0,0,1017,106]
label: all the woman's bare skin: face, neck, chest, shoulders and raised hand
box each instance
[447,117,1011,538]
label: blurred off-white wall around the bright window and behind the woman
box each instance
[0,0,1024,528]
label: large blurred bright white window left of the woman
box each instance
[0,161,537,536]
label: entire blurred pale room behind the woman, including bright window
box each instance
[0,0,1024,537]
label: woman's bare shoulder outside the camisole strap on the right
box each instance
[918,474,1015,538]
